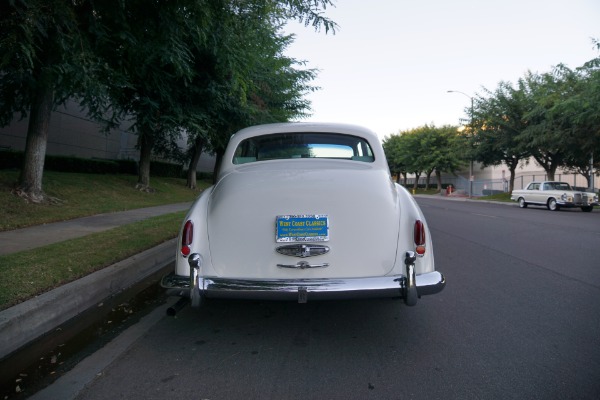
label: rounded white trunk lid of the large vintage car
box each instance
[207,160,399,279]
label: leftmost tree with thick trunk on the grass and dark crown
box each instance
[0,0,104,202]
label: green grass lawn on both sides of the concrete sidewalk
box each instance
[0,170,210,310]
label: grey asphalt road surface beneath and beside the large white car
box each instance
[40,199,600,400]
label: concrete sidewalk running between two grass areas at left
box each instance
[0,202,192,255]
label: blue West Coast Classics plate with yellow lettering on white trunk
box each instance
[275,214,329,243]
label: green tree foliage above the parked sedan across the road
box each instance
[473,46,600,186]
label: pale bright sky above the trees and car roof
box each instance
[285,0,600,139]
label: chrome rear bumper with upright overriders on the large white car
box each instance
[161,251,446,307]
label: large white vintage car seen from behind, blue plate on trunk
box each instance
[161,123,445,306]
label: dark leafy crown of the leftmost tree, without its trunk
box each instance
[0,0,100,126]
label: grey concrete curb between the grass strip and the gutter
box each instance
[0,239,177,359]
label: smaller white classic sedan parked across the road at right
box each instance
[510,181,598,212]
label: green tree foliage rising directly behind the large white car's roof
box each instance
[180,2,328,161]
